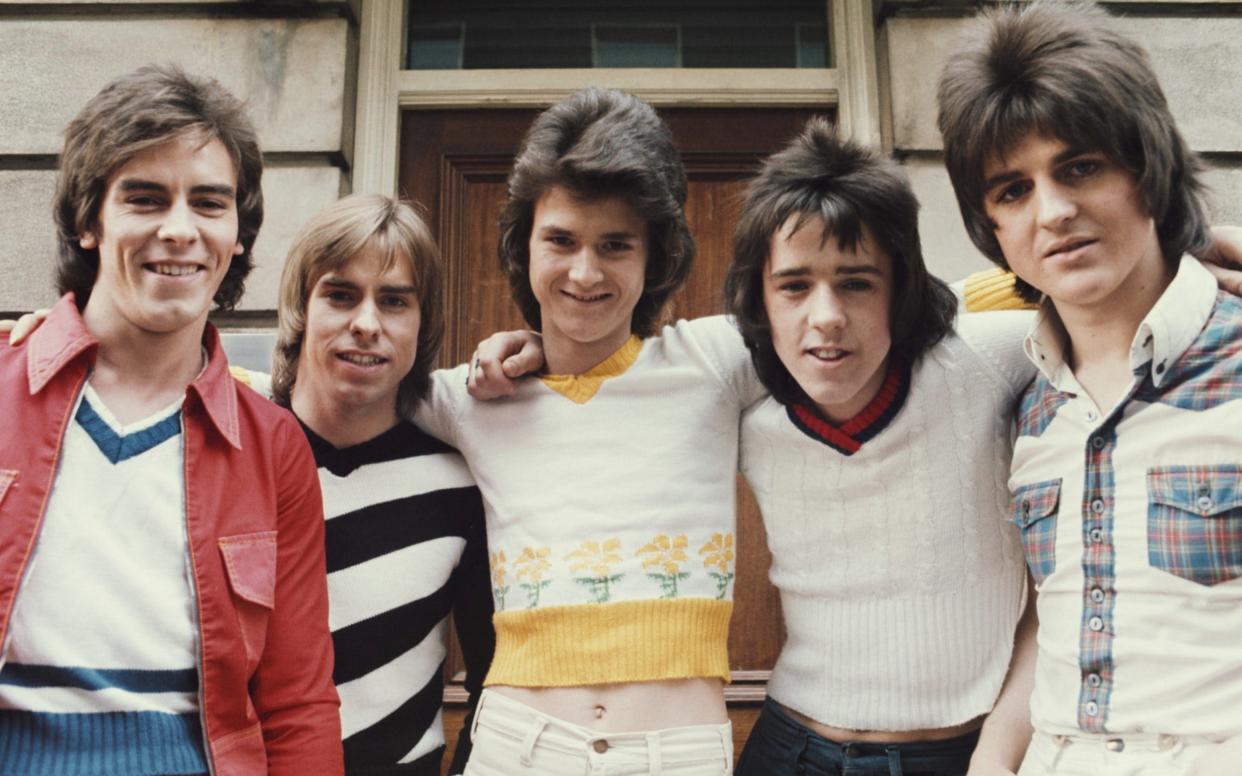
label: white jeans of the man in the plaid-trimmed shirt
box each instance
[1017,733,1217,776]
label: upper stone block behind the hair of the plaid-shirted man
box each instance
[884,16,1242,151]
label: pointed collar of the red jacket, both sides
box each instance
[26,293,241,449]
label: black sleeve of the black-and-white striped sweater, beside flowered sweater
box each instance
[448,488,496,774]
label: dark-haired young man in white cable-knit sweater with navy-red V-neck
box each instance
[725,120,1035,776]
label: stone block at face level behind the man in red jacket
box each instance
[0,166,340,312]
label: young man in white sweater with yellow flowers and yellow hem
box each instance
[417,89,759,776]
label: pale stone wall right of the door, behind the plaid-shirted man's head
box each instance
[878,0,1242,279]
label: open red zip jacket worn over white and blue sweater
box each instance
[0,294,344,776]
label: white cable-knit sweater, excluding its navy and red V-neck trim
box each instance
[741,306,1033,731]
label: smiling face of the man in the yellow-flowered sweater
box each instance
[530,186,647,374]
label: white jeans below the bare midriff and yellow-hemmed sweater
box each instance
[466,690,733,776]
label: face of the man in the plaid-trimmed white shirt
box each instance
[984,133,1171,317]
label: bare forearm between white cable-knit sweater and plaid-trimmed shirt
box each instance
[970,577,1040,776]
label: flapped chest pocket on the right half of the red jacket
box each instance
[219,531,276,670]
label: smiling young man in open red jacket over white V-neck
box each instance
[0,67,342,776]
